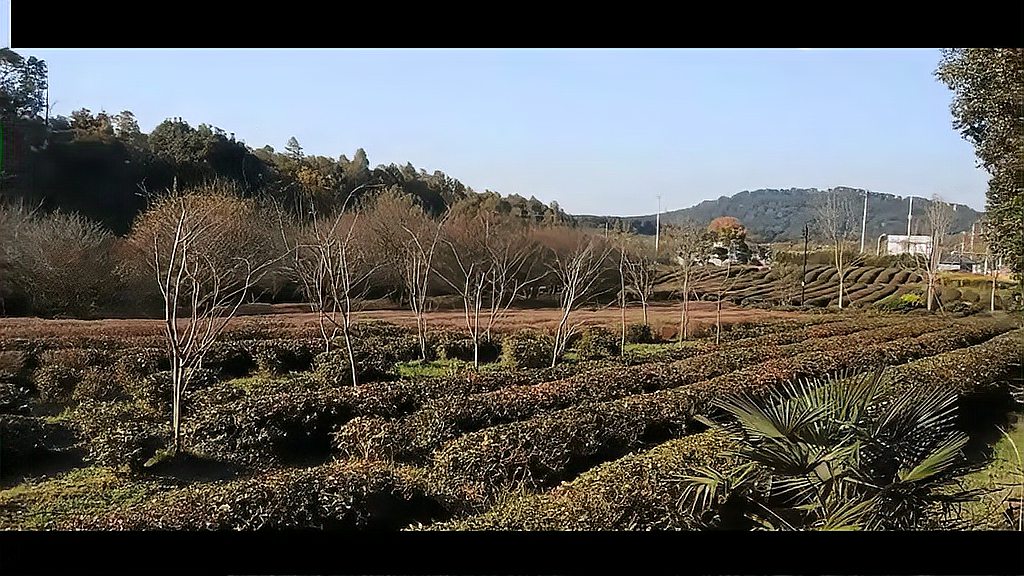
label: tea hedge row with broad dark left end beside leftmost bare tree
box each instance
[185,317,847,466]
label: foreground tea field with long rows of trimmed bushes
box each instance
[0,309,1024,530]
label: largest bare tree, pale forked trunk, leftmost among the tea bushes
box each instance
[130,184,281,453]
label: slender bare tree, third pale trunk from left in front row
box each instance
[367,188,451,360]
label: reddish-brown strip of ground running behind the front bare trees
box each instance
[0,302,799,338]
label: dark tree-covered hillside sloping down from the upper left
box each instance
[0,48,566,234]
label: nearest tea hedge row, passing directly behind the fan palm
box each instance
[436,329,1024,530]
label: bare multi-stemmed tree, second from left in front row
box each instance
[282,191,382,385]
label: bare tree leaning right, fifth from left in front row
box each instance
[547,229,611,367]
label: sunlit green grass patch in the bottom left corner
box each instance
[0,466,173,530]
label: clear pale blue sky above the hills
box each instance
[17,48,988,215]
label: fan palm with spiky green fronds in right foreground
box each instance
[680,371,978,530]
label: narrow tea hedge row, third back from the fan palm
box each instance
[335,319,939,461]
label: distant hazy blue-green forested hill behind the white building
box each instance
[577,187,982,242]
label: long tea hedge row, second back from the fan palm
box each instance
[430,320,1011,506]
